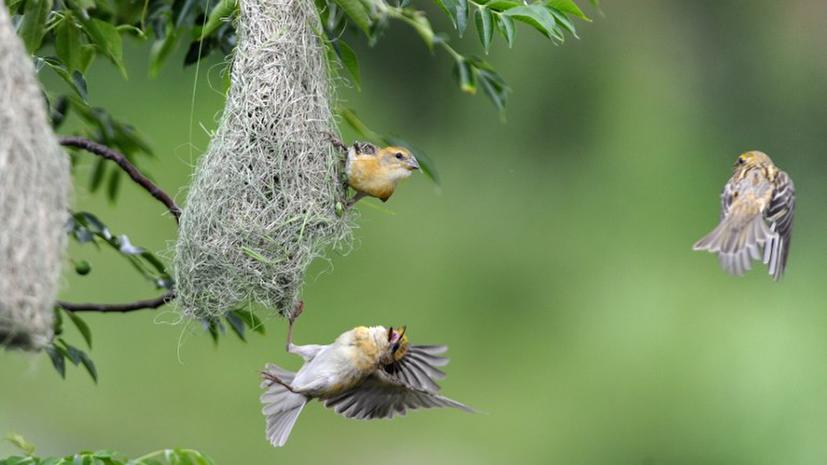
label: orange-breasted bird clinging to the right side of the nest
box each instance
[345,142,419,205]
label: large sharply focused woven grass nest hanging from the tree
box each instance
[175,0,351,318]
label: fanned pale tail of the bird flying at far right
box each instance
[692,214,777,276]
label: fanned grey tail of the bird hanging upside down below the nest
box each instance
[261,363,308,447]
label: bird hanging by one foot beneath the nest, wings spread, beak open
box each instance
[261,304,473,447]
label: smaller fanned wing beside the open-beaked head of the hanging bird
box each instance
[383,345,448,392]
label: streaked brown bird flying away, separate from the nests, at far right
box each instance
[693,150,795,281]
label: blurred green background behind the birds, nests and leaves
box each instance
[0,0,827,465]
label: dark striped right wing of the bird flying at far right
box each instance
[764,171,795,281]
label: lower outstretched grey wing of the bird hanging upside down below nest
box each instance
[324,371,474,420]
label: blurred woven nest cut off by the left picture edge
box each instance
[0,6,70,350]
